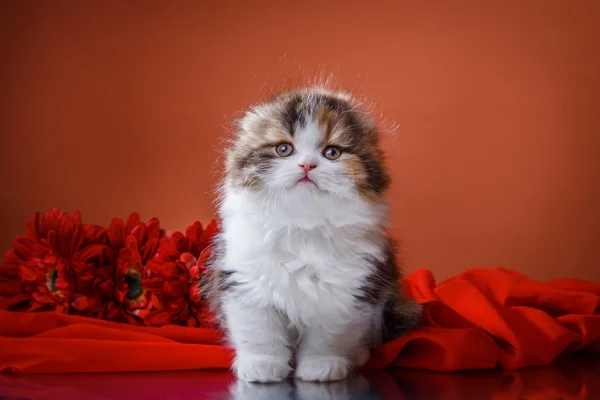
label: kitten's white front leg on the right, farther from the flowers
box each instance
[295,305,373,382]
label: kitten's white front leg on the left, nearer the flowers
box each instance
[223,297,291,382]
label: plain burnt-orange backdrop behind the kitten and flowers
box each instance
[0,0,600,281]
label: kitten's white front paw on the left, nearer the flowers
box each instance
[233,354,291,383]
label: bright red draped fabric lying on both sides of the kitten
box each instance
[0,269,600,374]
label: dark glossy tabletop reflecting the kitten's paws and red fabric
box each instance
[0,356,600,400]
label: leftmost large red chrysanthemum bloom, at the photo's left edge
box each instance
[0,209,105,312]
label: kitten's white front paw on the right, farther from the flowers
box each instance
[296,356,350,382]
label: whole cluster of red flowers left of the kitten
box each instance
[0,209,217,327]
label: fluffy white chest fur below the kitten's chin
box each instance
[222,184,382,329]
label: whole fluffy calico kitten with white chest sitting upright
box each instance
[204,89,420,382]
